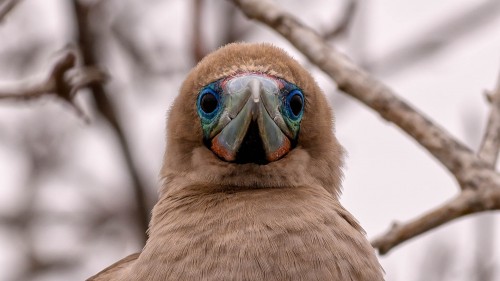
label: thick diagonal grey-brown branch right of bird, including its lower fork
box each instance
[232,0,500,254]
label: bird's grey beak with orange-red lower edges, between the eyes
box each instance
[211,73,296,162]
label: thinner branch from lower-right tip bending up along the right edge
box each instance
[372,75,500,255]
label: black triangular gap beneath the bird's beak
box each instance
[234,121,269,165]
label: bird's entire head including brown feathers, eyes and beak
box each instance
[162,43,342,195]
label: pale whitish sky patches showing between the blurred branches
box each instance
[0,0,500,281]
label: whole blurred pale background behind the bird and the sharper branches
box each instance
[0,0,500,281]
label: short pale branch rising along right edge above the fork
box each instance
[478,71,500,167]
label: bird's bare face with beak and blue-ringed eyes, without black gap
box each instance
[197,73,305,162]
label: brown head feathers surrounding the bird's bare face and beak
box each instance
[161,43,342,196]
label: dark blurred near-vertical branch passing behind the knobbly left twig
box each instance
[73,0,150,242]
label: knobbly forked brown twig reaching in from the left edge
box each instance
[0,51,107,119]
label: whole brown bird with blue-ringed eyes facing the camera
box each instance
[88,43,384,281]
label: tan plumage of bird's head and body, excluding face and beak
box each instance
[89,44,383,281]
